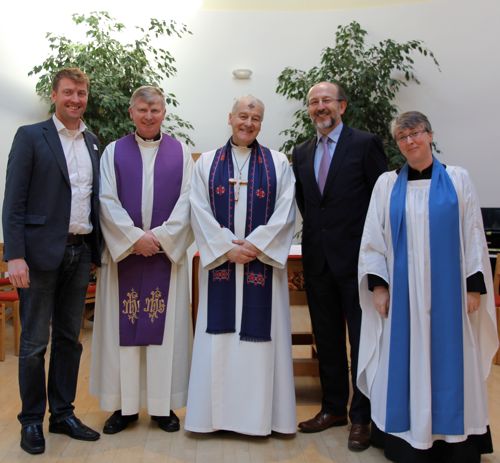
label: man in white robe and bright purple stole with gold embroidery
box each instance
[90,86,192,434]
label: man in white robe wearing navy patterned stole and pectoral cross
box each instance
[185,96,296,435]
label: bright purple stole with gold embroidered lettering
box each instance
[115,134,183,346]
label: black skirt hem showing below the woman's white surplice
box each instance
[371,423,493,463]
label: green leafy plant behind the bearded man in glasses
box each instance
[276,21,439,167]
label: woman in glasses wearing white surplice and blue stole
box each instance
[358,111,498,463]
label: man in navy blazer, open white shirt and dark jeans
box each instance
[2,68,100,454]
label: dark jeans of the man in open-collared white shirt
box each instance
[18,243,91,425]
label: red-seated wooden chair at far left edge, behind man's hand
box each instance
[0,243,21,361]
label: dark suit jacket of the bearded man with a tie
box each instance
[292,125,387,277]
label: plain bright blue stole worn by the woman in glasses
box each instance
[385,158,464,435]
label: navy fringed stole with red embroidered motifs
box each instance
[207,140,277,342]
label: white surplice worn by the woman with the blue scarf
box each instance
[358,166,498,449]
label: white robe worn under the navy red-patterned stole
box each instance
[185,146,296,435]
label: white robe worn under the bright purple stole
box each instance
[90,137,193,416]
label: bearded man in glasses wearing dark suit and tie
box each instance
[292,82,387,450]
